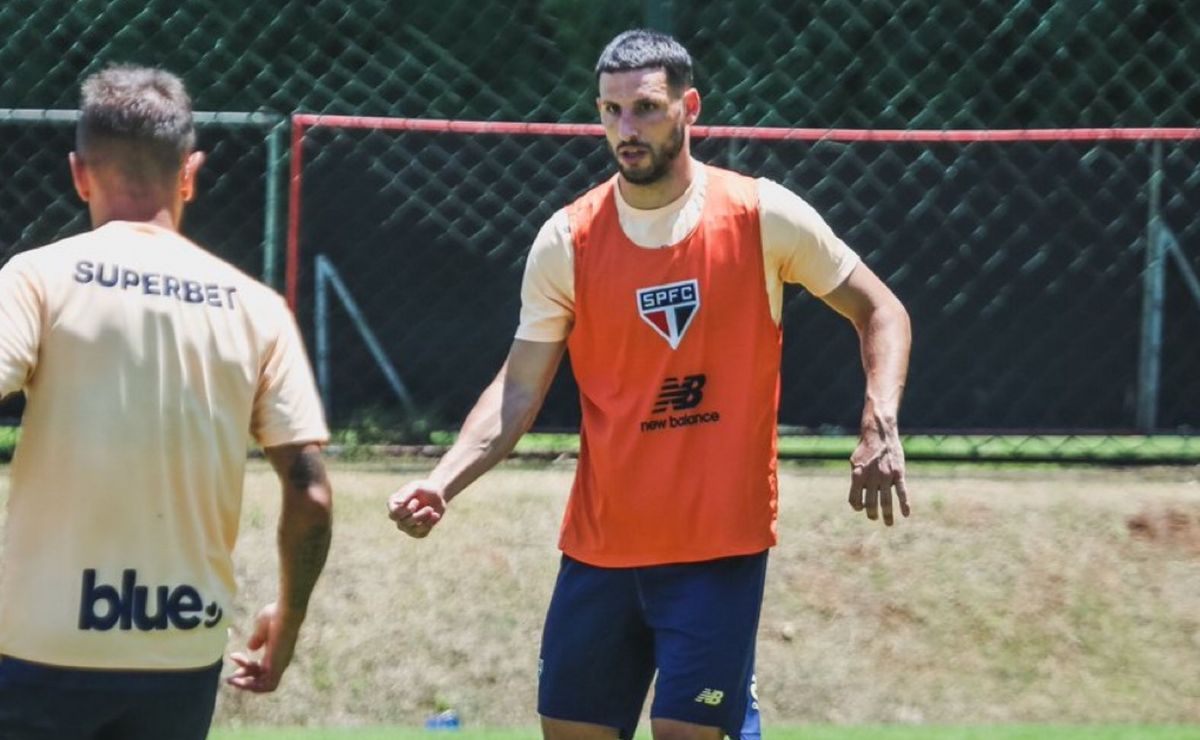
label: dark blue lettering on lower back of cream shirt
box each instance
[79,568,223,632]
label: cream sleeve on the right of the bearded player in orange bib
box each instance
[758,178,859,296]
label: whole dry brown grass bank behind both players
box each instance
[0,464,1200,726]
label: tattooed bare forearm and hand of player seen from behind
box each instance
[228,444,334,692]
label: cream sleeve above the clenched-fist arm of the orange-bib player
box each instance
[516,209,575,342]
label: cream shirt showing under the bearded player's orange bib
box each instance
[516,161,859,342]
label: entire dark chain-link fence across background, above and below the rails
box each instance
[0,0,1200,455]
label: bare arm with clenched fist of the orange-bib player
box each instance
[388,339,566,537]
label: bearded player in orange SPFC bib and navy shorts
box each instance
[389,31,911,740]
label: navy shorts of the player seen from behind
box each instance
[0,657,221,740]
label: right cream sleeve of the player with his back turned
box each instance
[251,301,329,447]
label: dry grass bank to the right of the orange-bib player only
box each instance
[760,471,1200,723]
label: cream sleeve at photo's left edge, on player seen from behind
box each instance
[0,255,44,397]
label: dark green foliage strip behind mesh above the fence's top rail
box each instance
[0,0,1200,128]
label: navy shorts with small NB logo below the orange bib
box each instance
[538,552,767,740]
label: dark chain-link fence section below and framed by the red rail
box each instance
[294,119,1200,432]
